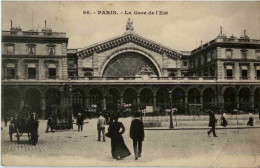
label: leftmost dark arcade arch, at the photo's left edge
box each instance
[2,88,20,117]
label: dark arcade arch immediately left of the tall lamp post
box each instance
[156,87,170,111]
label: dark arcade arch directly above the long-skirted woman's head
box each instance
[106,88,121,112]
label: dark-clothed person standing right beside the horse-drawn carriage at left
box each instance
[29,113,39,146]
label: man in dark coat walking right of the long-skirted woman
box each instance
[130,112,144,160]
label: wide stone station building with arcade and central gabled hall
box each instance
[2,20,260,122]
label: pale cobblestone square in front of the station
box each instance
[1,118,260,167]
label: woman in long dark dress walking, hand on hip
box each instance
[106,115,131,160]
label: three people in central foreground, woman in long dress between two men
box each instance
[97,112,144,160]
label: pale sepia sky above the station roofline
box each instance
[2,1,260,51]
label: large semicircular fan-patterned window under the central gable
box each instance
[103,52,158,77]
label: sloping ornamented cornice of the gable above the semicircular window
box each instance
[76,33,182,59]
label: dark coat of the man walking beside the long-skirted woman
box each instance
[130,119,144,140]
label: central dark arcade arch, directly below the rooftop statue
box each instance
[123,88,138,113]
